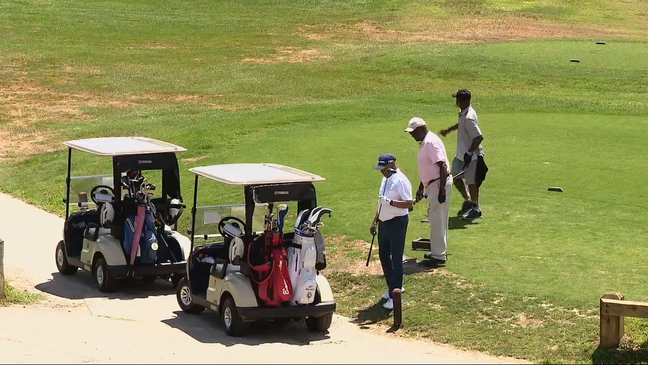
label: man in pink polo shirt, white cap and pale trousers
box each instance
[405,117,452,265]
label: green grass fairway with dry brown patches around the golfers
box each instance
[0,0,648,363]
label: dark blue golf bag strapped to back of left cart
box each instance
[124,207,158,264]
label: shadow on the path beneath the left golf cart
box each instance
[35,270,175,300]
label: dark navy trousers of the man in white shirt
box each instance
[378,215,409,298]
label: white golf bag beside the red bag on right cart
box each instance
[288,230,317,305]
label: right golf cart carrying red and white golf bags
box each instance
[176,164,336,336]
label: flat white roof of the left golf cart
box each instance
[63,137,187,157]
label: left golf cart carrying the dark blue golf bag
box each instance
[56,137,191,292]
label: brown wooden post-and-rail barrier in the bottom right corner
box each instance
[599,293,648,350]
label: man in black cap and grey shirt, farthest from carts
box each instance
[440,89,488,220]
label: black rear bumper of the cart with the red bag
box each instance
[236,302,336,321]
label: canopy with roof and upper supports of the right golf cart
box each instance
[189,163,326,235]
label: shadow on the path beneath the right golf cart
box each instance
[162,311,330,347]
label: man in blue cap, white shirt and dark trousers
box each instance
[370,153,414,309]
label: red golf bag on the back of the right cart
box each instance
[248,220,293,306]
